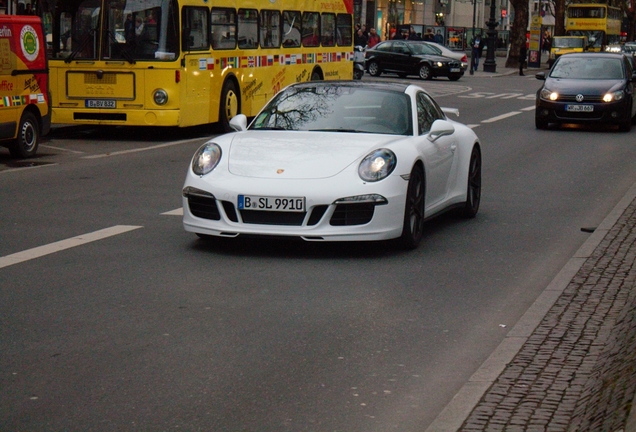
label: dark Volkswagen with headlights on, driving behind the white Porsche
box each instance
[535,53,636,132]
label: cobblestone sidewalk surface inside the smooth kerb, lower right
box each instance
[461,200,636,431]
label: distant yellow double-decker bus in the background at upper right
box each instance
[565,3,623,51]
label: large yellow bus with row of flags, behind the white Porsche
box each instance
[40,0,353,130]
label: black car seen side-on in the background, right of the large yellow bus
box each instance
[365,40,464,81]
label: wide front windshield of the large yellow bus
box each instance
[51,0,179,63]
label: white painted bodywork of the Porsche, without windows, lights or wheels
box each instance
[183,81,479,241]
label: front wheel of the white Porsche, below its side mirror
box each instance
[400,165,426,249]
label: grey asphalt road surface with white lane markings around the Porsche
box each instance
[0,76,636,432]
